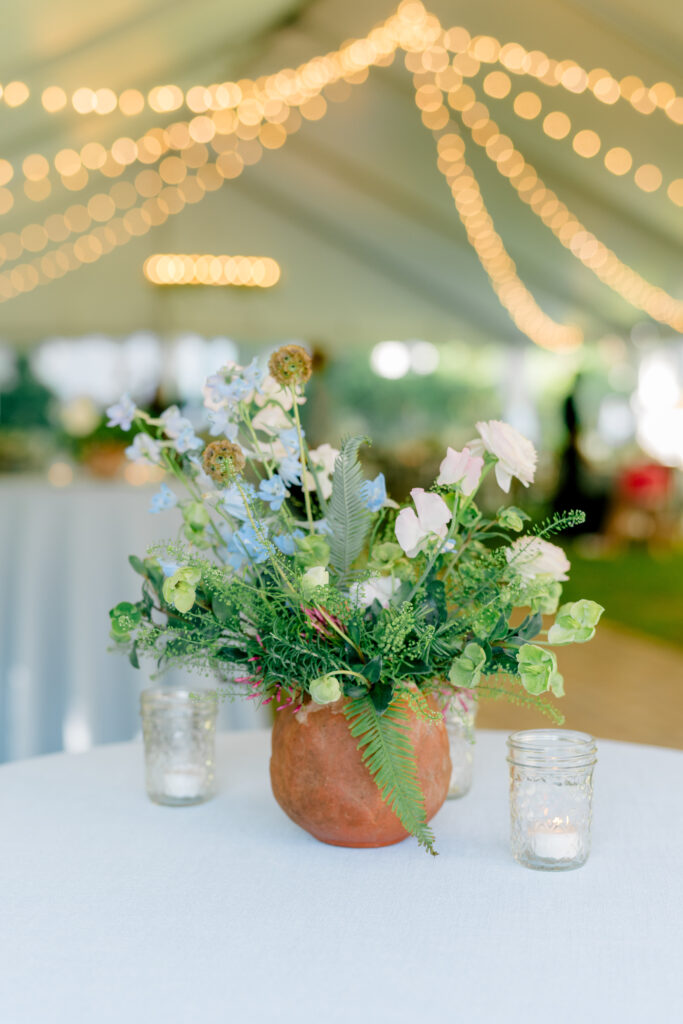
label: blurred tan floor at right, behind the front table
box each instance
[477,624,683,749]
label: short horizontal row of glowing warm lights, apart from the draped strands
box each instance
[142,253,280,288]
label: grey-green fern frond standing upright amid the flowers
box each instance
[327,437,371,583]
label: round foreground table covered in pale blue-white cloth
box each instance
[0,731,683,1024]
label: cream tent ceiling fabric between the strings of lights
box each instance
[0,0,683,346]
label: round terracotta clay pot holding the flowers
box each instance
[270,698,451,847]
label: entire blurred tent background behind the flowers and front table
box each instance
[0,0,683,761]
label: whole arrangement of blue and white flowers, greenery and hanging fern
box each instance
[108,345,603,852]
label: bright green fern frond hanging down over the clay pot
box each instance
[344,695,436,856]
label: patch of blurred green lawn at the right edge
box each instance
[562,546,683,647]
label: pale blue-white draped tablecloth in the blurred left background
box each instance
[0,479,266,761]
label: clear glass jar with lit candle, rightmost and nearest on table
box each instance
[508,729,597,871]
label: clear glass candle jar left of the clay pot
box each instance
[140,689,218,807]
